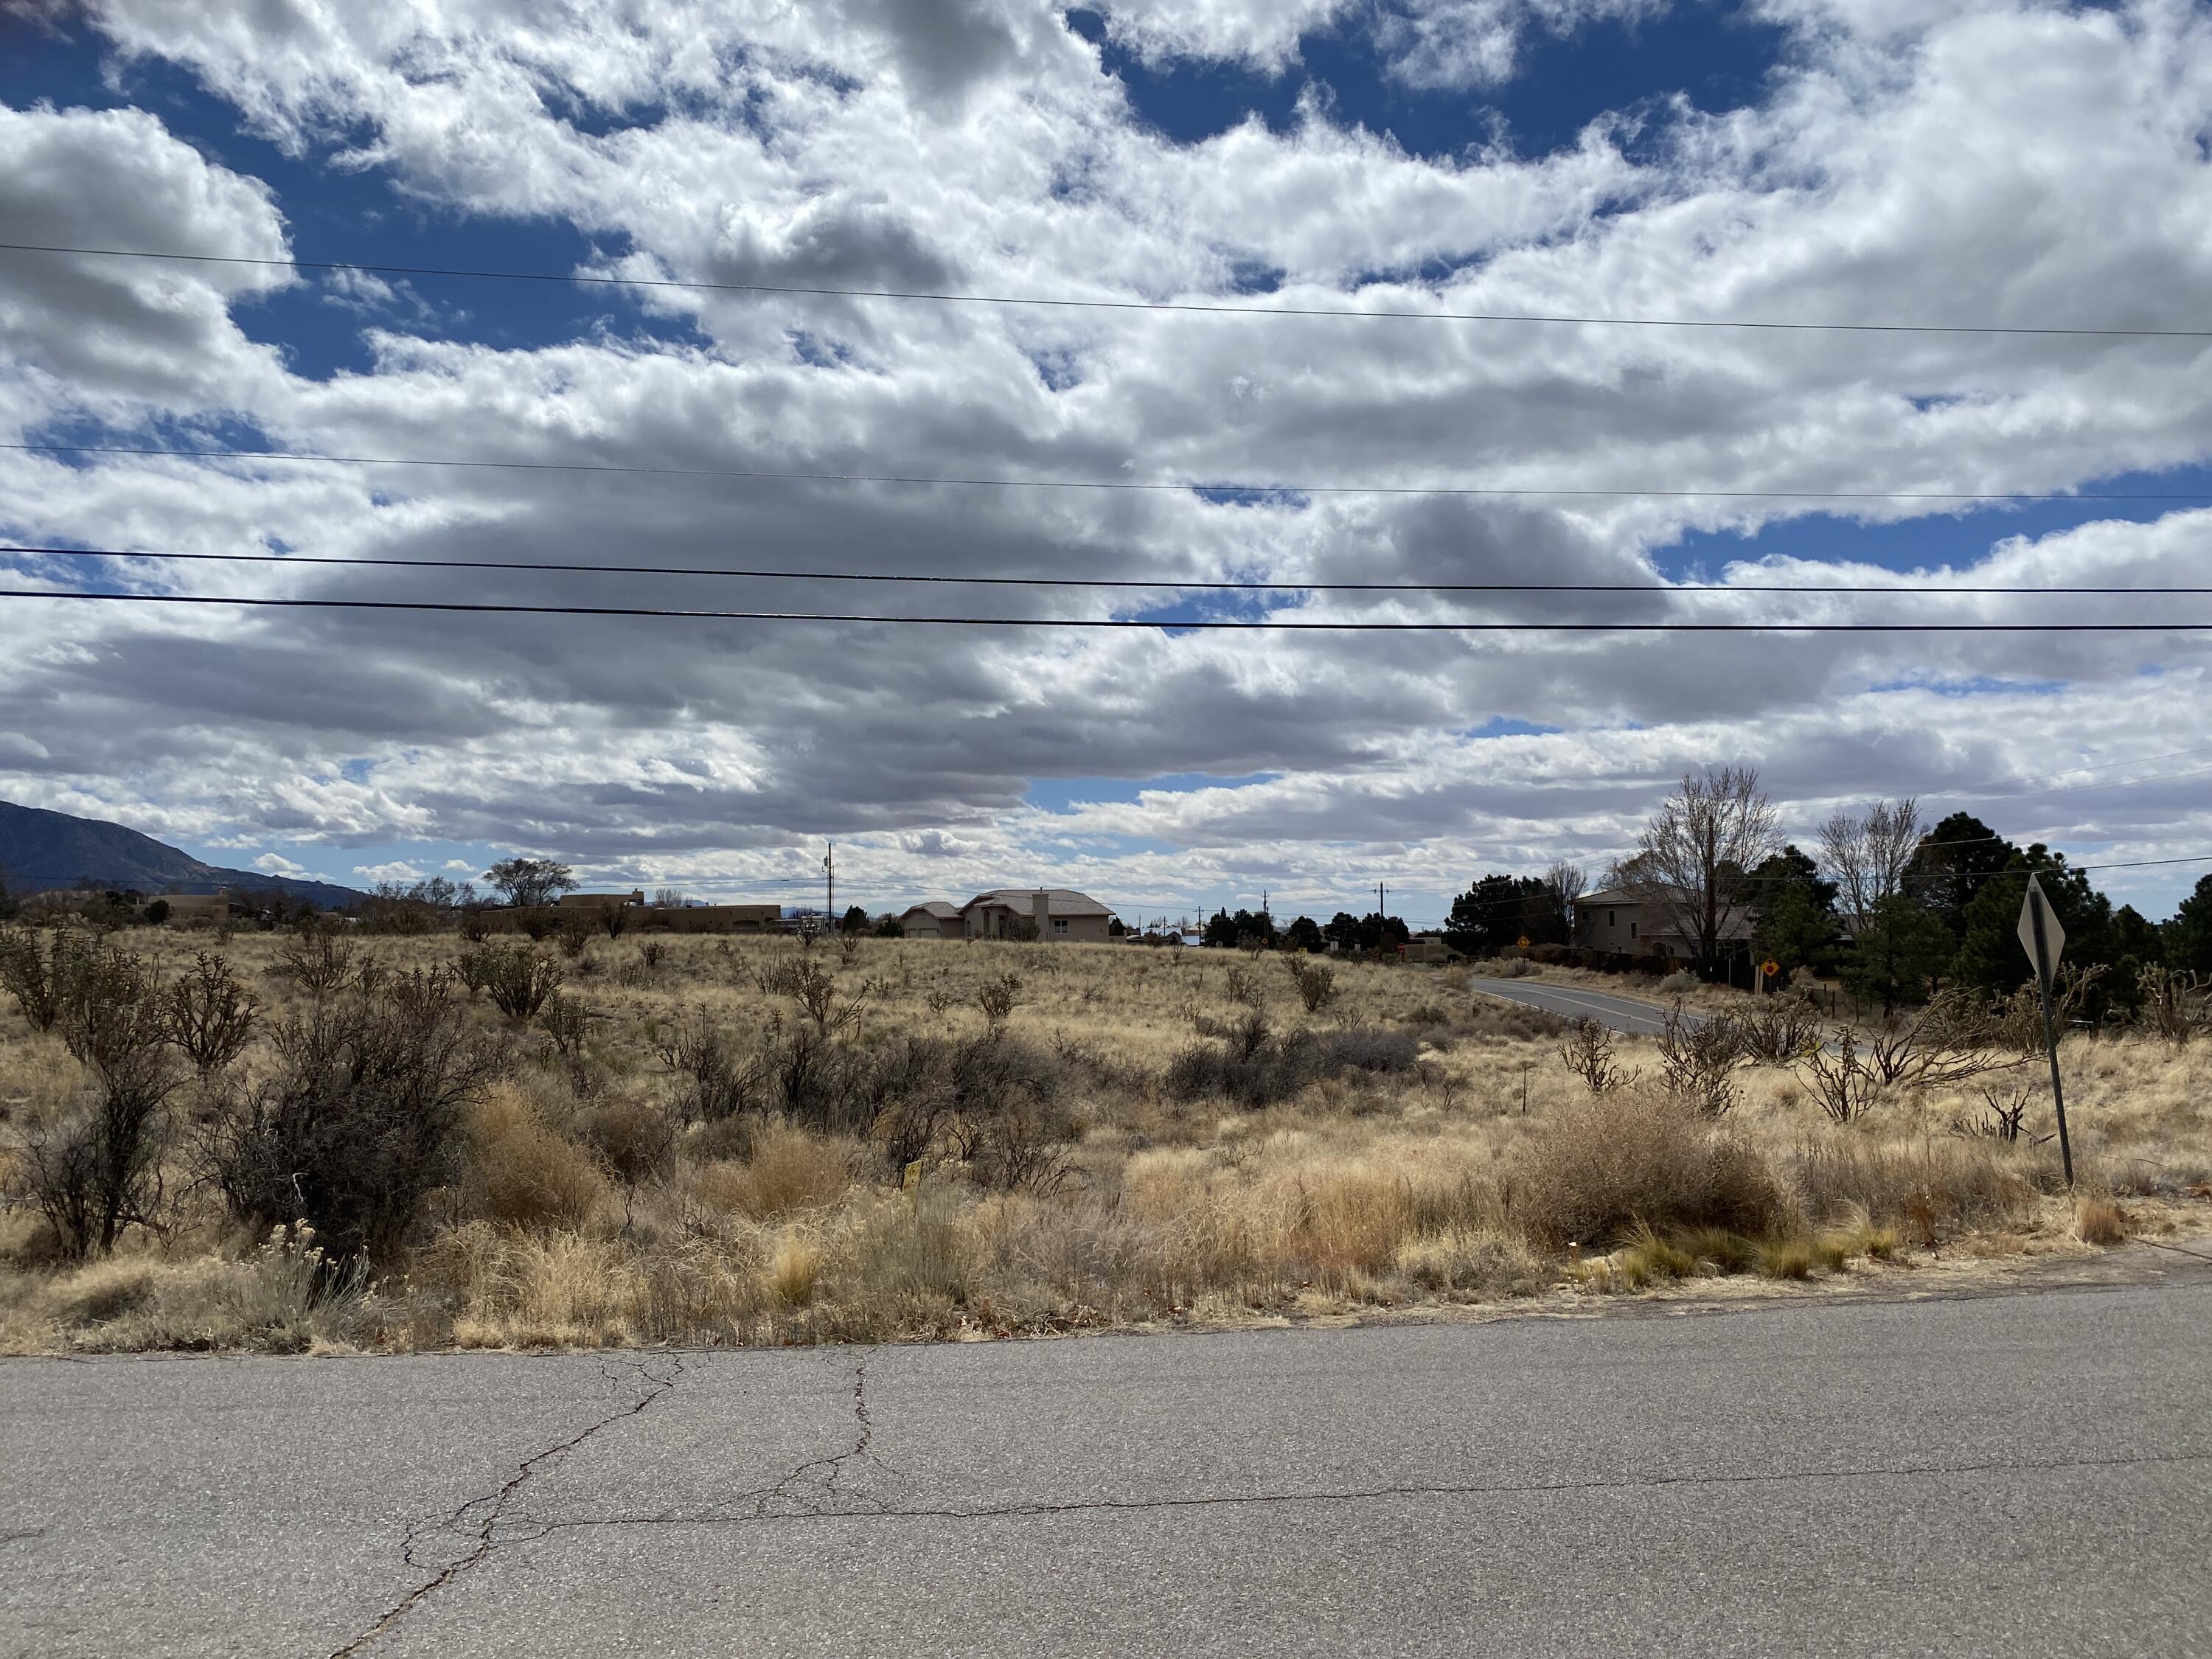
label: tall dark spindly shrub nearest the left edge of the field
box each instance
[20,949,184,1256]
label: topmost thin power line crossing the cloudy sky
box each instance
[0,241,2212,341]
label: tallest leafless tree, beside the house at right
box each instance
[1608,765,1774,971]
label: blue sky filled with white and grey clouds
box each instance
[0,0,2212,922]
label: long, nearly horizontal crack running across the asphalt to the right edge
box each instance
[489,1453,2212,1537]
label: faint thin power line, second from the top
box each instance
[17,442,2212,502]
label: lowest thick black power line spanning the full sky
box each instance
[0,588,2212,633]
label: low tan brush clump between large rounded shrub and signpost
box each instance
[1792,1135,2035,1245]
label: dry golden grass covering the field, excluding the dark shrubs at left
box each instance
[0,931,2212,1352]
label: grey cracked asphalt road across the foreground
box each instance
[0,1261,2212,1659]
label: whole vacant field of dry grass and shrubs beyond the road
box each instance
[0,931,2212,1352]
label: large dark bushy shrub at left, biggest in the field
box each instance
[204,973,495,1261]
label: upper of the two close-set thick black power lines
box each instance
[13,544,2212,597]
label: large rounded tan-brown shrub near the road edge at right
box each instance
[1500,1091,1787,1248]
